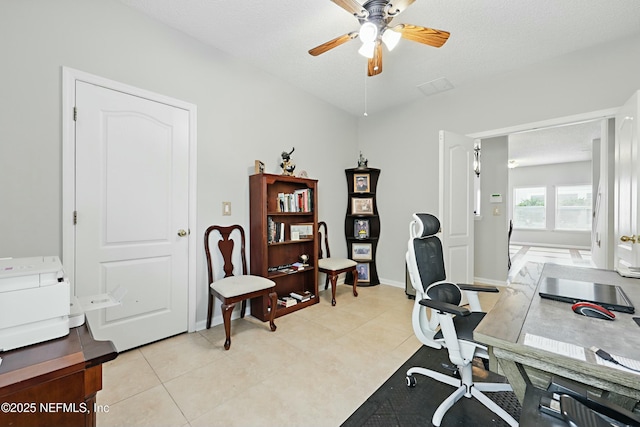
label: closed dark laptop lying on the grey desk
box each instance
[538,277,635,313]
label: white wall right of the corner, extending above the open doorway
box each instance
[358,36,640,282]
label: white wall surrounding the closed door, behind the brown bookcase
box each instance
[0,0,358,321]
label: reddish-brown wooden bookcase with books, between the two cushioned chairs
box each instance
[249,174,320,321]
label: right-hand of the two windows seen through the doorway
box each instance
[556,185,591,231]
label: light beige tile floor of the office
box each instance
[97,285,496,427]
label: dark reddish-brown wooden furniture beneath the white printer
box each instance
[0,325,118,427]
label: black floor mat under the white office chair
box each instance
[342,346,520,427]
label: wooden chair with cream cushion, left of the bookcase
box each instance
[204,225,278,350]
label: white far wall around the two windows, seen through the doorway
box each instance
[507,161,593,248]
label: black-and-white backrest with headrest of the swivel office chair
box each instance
[407,213,447,294]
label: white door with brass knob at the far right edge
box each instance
[614,92,640,277]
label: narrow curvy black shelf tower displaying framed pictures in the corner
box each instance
[344,168,380,286]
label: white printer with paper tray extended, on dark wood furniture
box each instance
[0,256,124,352]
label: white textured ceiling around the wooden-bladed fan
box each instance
[121,0,640,115]
